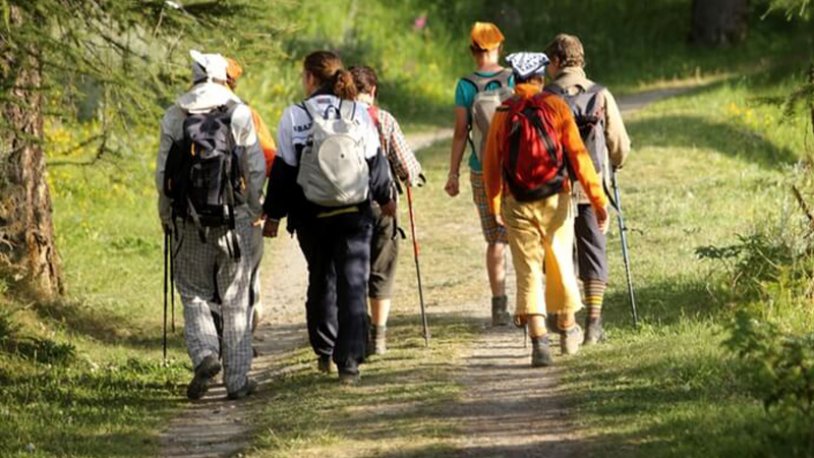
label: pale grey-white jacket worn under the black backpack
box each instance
[155,82,266,224]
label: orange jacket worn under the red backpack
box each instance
[483,84,608,215]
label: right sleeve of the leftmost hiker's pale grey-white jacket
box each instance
[232,105,266,219]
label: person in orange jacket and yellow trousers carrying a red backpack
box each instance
[483,52,608,367]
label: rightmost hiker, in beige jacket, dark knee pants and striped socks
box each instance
[545,33,630,345]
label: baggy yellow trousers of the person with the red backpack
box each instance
[502,192,582,316]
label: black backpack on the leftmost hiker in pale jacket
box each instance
[164,101,248,234]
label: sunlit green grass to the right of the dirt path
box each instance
[565,70,812,457]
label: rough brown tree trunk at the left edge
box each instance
[0,6,63,297]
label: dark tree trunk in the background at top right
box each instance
[690,0,749,46]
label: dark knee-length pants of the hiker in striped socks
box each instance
[574,204,608,283]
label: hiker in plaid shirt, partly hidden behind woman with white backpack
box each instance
[350,67,422,355]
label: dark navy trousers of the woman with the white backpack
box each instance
[297,213,373,371]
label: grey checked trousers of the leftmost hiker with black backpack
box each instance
[173,220,253,393]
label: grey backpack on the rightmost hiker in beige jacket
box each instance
[545,84,608,176]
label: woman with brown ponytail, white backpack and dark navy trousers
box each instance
[263,51,396,384]
